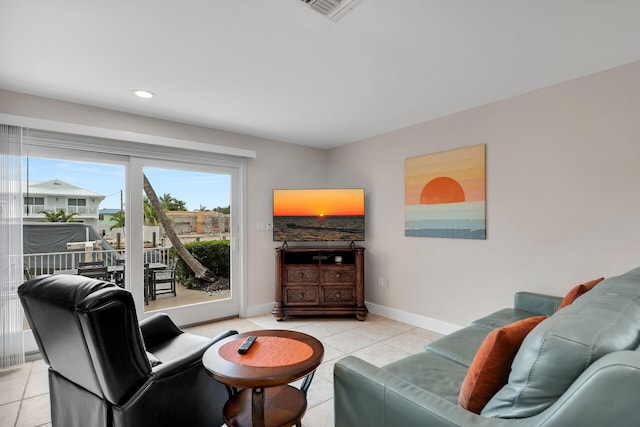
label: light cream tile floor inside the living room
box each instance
[0,314,440,427]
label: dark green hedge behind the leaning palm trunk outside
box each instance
[169,240,231,288]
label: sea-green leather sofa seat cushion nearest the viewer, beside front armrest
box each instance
[382,352,467,405]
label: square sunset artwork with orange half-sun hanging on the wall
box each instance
[404,144,487,240]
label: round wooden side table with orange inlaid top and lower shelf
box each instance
[202,329,324,427]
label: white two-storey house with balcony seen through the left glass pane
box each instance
[22,178,105,230]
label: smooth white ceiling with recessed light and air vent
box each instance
[0,0,640,148]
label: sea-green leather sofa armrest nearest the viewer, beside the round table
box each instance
[333,356,510,427]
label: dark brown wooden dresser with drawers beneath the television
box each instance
[271,246,368,320]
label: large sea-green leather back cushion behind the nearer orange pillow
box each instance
[481,268,640,418]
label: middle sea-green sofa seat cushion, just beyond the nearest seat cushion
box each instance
[424,325,491,368]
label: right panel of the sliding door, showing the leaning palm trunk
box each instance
[133,159,239,323]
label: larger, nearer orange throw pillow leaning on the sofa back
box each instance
[458,316,548,414]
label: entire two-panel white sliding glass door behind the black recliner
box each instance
[23,135,243,332]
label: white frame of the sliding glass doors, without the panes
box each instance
[23,136,246,326]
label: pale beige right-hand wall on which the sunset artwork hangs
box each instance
[328,58,640,332]
